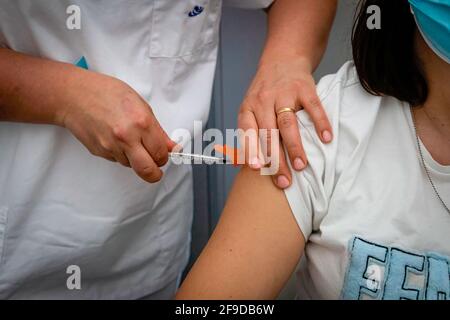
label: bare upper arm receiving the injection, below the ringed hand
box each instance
[177,168,305,299]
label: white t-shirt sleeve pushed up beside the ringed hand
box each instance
[285,65,345,240]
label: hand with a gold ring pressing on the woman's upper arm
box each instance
[238,56,332,189]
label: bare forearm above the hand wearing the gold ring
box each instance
[261,0,337,72]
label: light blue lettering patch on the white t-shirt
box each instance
[342,237,450,300]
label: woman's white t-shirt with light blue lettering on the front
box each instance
[286,62,450,299]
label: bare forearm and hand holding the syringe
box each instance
[0,49,176,182]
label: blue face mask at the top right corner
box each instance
[409,0,450,63]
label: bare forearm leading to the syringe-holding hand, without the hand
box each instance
[0,49,83,124]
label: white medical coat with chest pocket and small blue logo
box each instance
[0,0,272,299]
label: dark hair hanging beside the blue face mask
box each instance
[352,0,428,106]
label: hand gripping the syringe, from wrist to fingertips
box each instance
[59,70,175,182]
